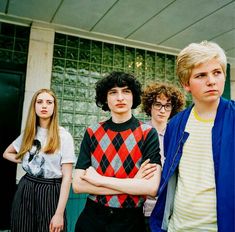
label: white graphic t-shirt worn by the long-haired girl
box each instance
[13,127,76,179]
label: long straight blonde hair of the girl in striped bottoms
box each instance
[16,89,60,159]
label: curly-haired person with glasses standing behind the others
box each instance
[142,83,185,231]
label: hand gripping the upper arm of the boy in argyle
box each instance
[134,159,157,180]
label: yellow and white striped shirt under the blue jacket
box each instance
[168,109,217,232]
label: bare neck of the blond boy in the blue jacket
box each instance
[194,101,219,120]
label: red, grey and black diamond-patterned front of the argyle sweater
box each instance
[87,118,150,208]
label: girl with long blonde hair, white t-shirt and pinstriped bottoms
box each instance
[3,89,75,232]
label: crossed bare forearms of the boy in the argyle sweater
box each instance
[73,159,161,197]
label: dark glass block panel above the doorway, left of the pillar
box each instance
[0,22,30,64]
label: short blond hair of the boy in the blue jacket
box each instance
[176,41,227,85]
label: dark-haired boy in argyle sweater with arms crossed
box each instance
[73,72,161,232]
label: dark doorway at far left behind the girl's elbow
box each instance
[0,66,25,230]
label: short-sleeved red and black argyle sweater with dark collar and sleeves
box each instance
[76,116,161,208]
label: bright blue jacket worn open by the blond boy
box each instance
[150,98,235,232]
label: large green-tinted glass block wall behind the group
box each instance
[51,33,187,154]
